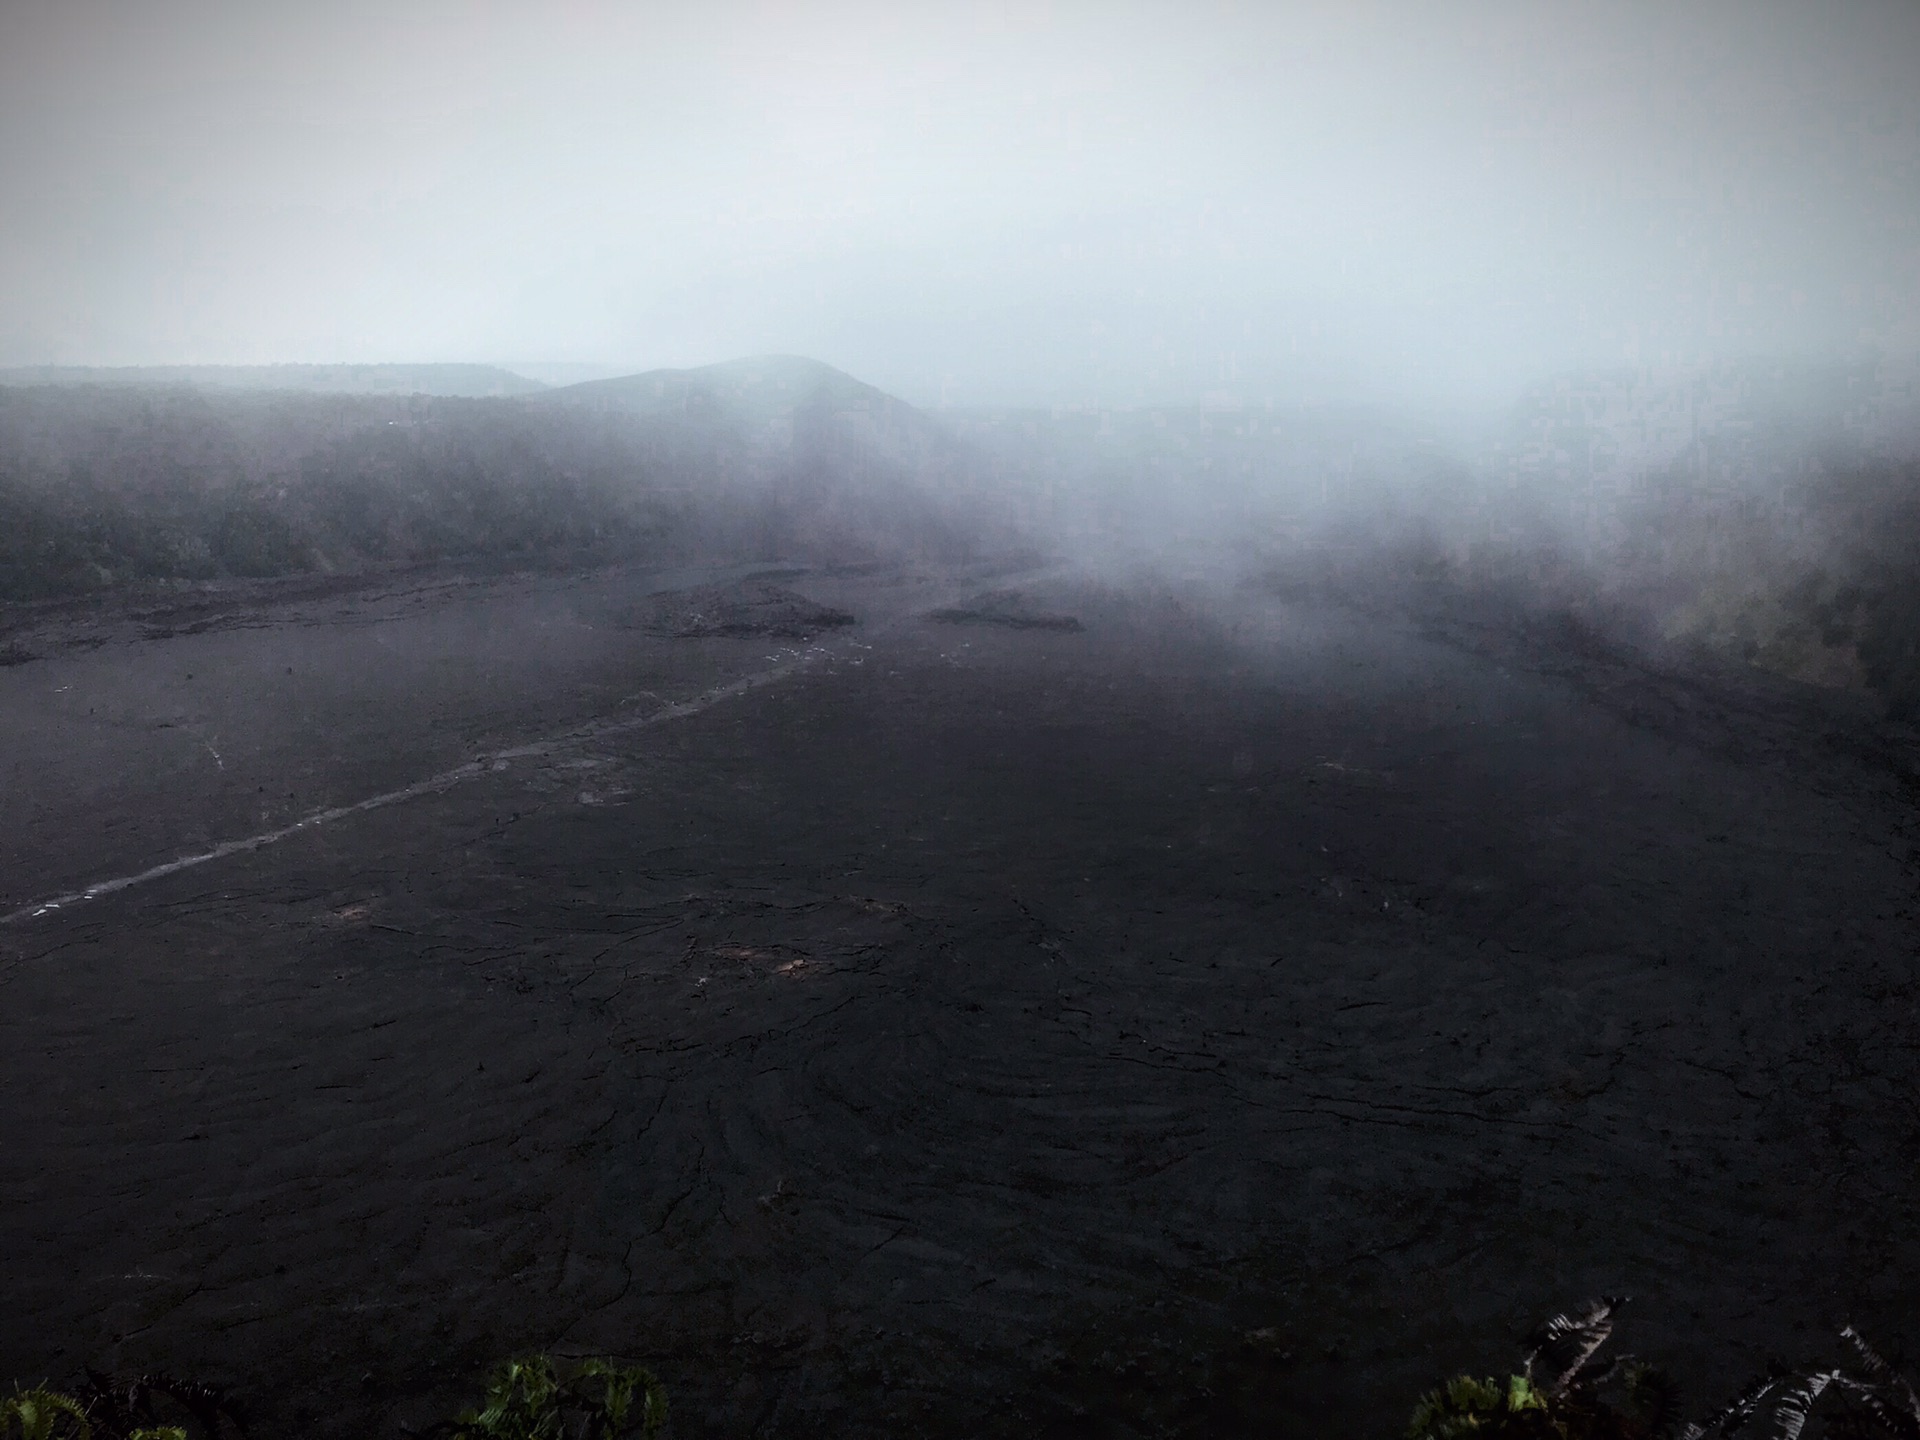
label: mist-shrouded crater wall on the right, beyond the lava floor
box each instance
[956,361,1920,718]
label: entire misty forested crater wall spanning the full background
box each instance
[11,357,1920,718]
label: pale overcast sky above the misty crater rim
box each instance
[0,0,1920,403]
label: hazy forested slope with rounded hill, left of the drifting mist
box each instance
[0,361,1016,599]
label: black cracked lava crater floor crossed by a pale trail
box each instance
[0,574,1920,1436]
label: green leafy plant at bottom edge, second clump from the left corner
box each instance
[419,1356,666,1440]
